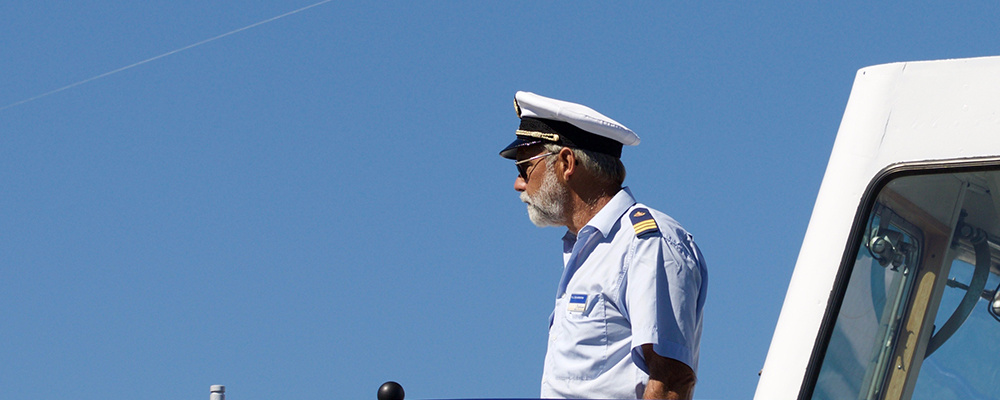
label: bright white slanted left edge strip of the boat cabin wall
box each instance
[755,64,903,399]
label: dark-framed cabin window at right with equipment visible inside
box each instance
[812,170,1000,400]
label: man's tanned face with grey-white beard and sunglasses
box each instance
[514,146,569,227]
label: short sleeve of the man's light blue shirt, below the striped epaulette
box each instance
[623,236,702,373]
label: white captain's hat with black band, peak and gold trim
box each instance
[500,92,639,160]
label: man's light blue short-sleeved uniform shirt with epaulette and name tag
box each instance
[541,188,708,399]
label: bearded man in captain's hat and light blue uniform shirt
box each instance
[500,92,708,399]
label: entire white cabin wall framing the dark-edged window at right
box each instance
[755,57,1000,399]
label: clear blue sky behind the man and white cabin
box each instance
[0,0,1000,400]
